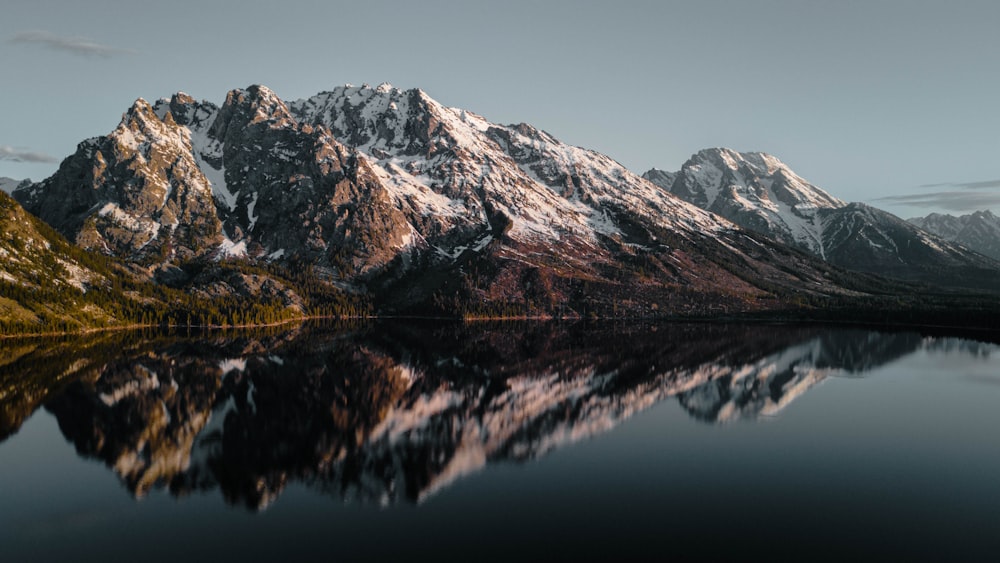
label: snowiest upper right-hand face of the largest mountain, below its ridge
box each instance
[290,84,731,242]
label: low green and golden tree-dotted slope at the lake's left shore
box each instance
[0,192,316,336]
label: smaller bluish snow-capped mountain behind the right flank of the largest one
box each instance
[644,148,1000,290]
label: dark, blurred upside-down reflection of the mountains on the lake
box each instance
[0,323,995,510]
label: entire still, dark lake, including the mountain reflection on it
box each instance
[0,324,1000,561]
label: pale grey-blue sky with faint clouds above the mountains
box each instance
[0,0,1000,217]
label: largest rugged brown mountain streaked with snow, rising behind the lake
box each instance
[7,84,884,314]
